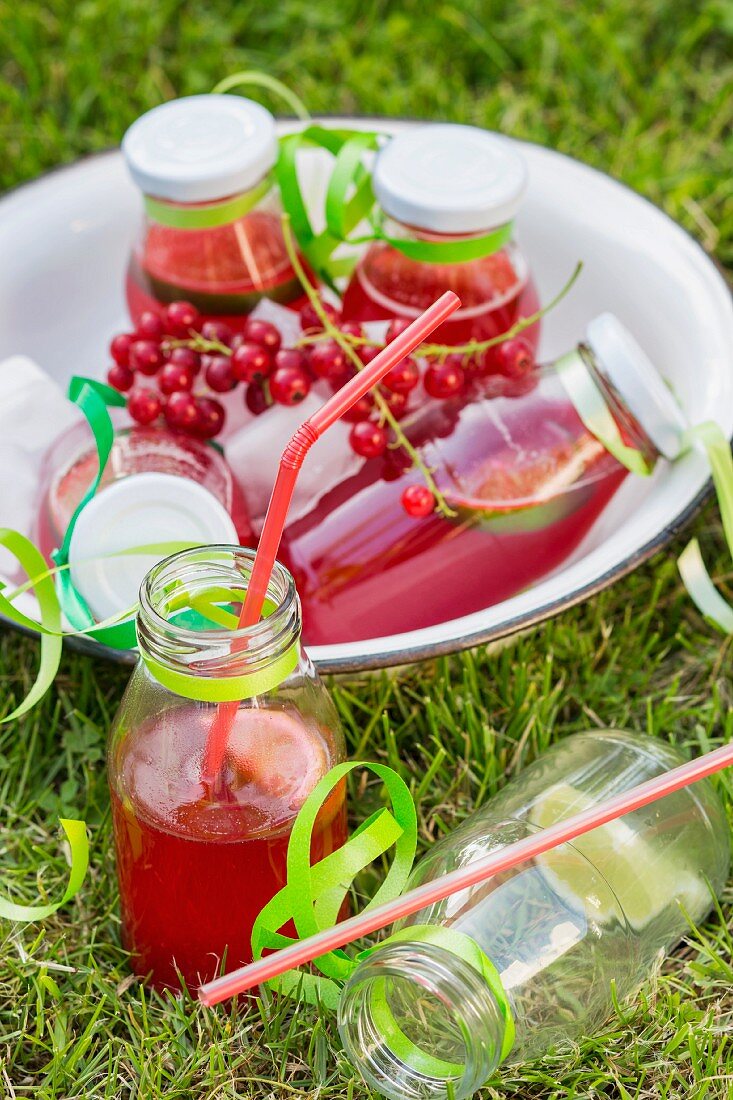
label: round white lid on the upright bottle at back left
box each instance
[122,96,277,202]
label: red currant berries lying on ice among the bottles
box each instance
[107,301,535,516]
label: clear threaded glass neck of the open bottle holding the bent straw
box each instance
[138,546,300,678]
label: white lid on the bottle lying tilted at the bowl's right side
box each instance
[587,314,688,459]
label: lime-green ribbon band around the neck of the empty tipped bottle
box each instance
[360,924,516,1079]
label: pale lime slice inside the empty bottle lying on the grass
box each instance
[529,783,710,930]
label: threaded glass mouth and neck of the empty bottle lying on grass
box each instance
[339,941,506,1100]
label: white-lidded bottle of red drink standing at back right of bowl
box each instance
[342,123,539,350]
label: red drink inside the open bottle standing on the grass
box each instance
[110,704,347,988]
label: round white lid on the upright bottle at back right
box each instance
[373,123,527,233]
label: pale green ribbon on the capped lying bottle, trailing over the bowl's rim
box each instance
[556,351,733,634]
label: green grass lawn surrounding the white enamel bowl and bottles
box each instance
[0,0,733,1100]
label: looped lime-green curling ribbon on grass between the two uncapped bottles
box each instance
[252,760,417,1009]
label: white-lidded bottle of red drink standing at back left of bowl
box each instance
[122,95,303,329]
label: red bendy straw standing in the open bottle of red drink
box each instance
[204,290,461,782]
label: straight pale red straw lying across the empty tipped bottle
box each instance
[198,744,733,1005]
